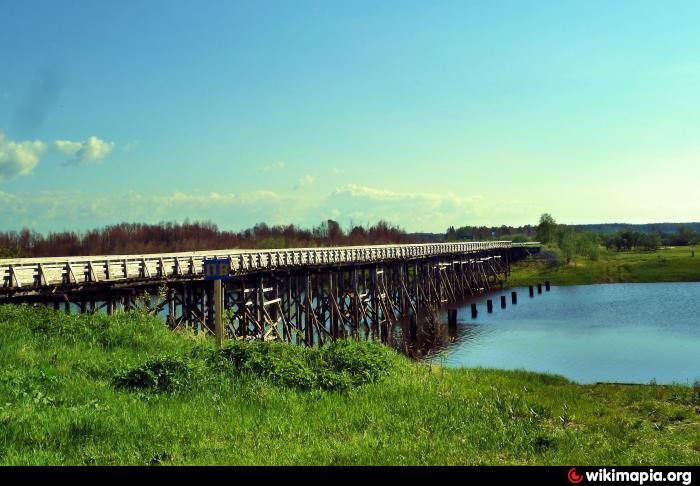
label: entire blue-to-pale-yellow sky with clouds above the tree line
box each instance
[0,0,700,232]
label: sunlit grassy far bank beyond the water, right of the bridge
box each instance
[508,246,700,287]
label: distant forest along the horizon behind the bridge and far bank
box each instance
[0,220,700,258]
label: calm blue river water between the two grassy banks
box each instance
[432,283,700,384]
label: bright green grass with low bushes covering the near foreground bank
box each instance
[0,306,700,465]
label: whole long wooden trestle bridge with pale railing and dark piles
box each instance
[0,241,539,345]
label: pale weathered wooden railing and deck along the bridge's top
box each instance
[0,241,539,293]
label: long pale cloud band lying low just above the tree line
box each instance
[0,184,541,232]
